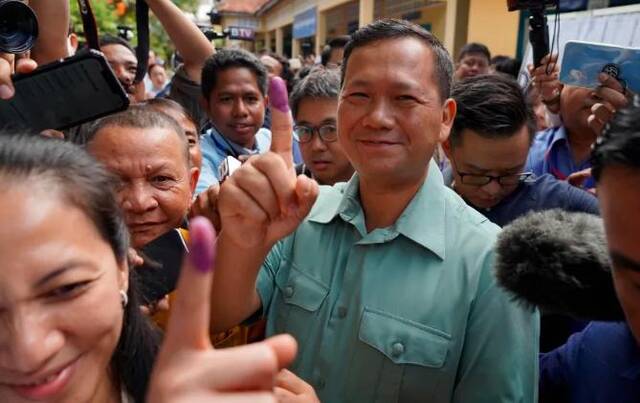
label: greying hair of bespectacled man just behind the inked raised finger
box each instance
[289,67,340,119]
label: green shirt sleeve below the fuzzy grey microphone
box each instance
[452,250,540,403]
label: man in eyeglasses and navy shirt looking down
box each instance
[443,75,599,226]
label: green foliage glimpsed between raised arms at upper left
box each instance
[71,0,198,67]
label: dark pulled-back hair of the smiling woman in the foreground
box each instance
[0,134,160,402]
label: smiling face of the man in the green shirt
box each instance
[338,37,455,187]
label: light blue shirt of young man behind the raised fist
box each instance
[196,127,302,194]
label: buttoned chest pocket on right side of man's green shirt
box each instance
[347,308,455,403]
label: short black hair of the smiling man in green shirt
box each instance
[340,18,453,101]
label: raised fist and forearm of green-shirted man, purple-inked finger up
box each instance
[212,77,319,332]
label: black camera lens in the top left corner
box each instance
[0,0,38,54]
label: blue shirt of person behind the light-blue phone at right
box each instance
[525,126,595,188]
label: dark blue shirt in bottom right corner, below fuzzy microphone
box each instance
[540,322,640,403]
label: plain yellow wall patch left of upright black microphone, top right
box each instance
[467,0,519,57]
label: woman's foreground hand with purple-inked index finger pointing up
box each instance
[147,217,296,403]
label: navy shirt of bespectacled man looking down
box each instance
[443,167,600,227]
